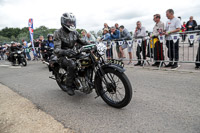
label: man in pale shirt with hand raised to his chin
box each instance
[134,21,147,66]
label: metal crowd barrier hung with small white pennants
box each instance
[103,30,200,69]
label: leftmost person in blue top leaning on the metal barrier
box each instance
[101,28,113,60]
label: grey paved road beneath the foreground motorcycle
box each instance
[0,62,200,133]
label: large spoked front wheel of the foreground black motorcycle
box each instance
[96,68,132,108]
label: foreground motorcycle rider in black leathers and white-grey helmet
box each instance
[54,13,89,95]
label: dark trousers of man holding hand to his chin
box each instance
[136,40,147,60]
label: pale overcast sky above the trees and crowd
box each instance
[0,0,200,31]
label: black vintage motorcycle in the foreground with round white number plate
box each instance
[49,43,132,108]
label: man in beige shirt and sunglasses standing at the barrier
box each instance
[151,14,164,66]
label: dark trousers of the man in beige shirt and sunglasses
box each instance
[153,41,164,62]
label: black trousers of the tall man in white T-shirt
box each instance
[166,40,179,61]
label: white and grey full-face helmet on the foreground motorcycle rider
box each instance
[61,13,76,31]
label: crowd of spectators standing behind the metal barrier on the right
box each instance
[91,9,200,69]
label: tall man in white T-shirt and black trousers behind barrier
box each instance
[165,9,181,69]
